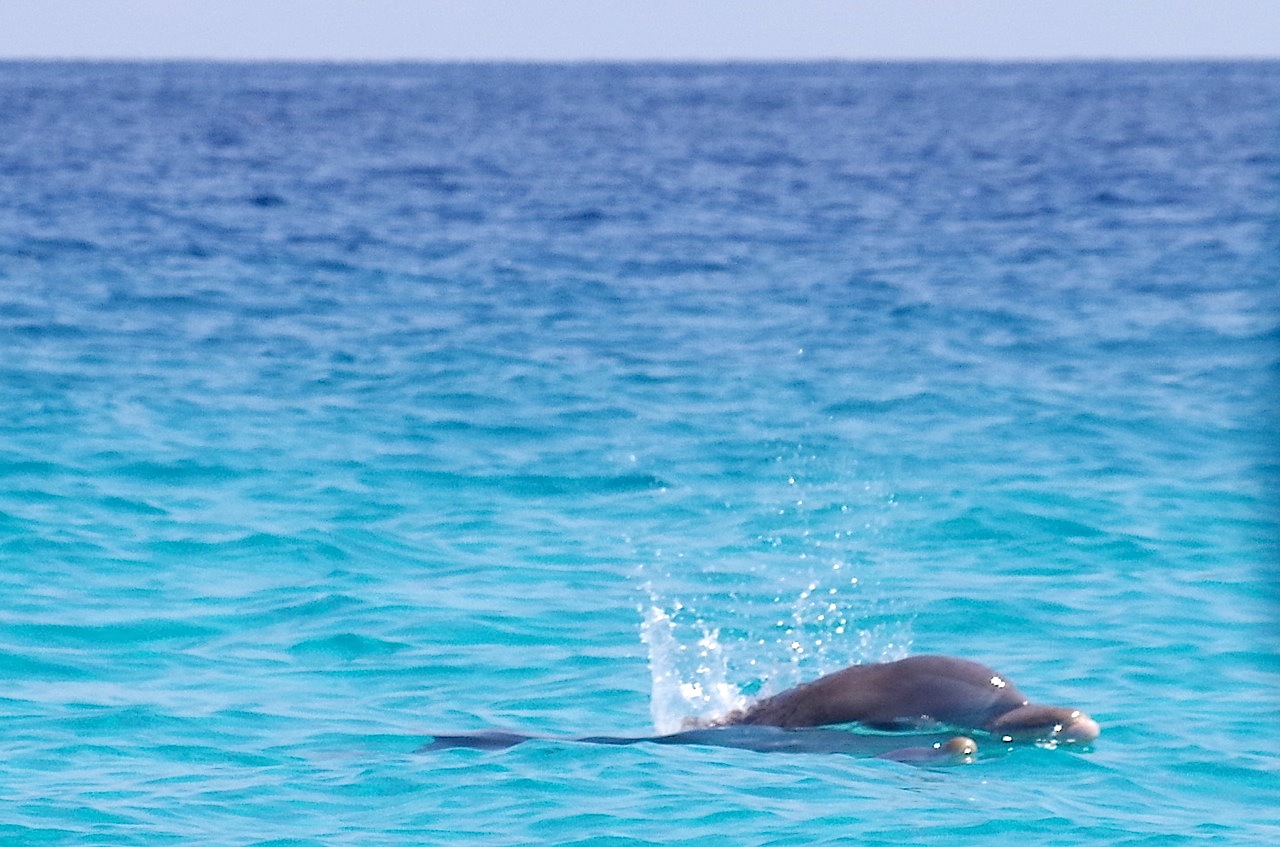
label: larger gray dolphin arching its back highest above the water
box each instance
[714,656,1101,743]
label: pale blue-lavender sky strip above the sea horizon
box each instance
[0,0,1280,60]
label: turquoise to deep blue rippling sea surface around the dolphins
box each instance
[0,63,1280,847]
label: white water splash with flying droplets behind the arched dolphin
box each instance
[628,460,913,732]
